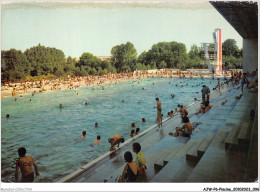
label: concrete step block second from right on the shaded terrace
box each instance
[225,125,240,149]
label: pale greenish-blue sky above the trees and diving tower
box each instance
[1,1,242,58]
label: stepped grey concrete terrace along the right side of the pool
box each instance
[58,78,258,183]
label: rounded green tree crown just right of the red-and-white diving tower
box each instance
[222,39,240,58]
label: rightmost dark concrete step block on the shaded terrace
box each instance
[238,122,251,151]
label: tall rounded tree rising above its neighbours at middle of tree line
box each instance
[111,42,137,72]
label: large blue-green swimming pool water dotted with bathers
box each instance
[1,78,217,182]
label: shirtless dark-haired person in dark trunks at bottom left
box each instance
[15,147,40,183]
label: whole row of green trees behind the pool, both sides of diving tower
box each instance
[1,39,242,82]
